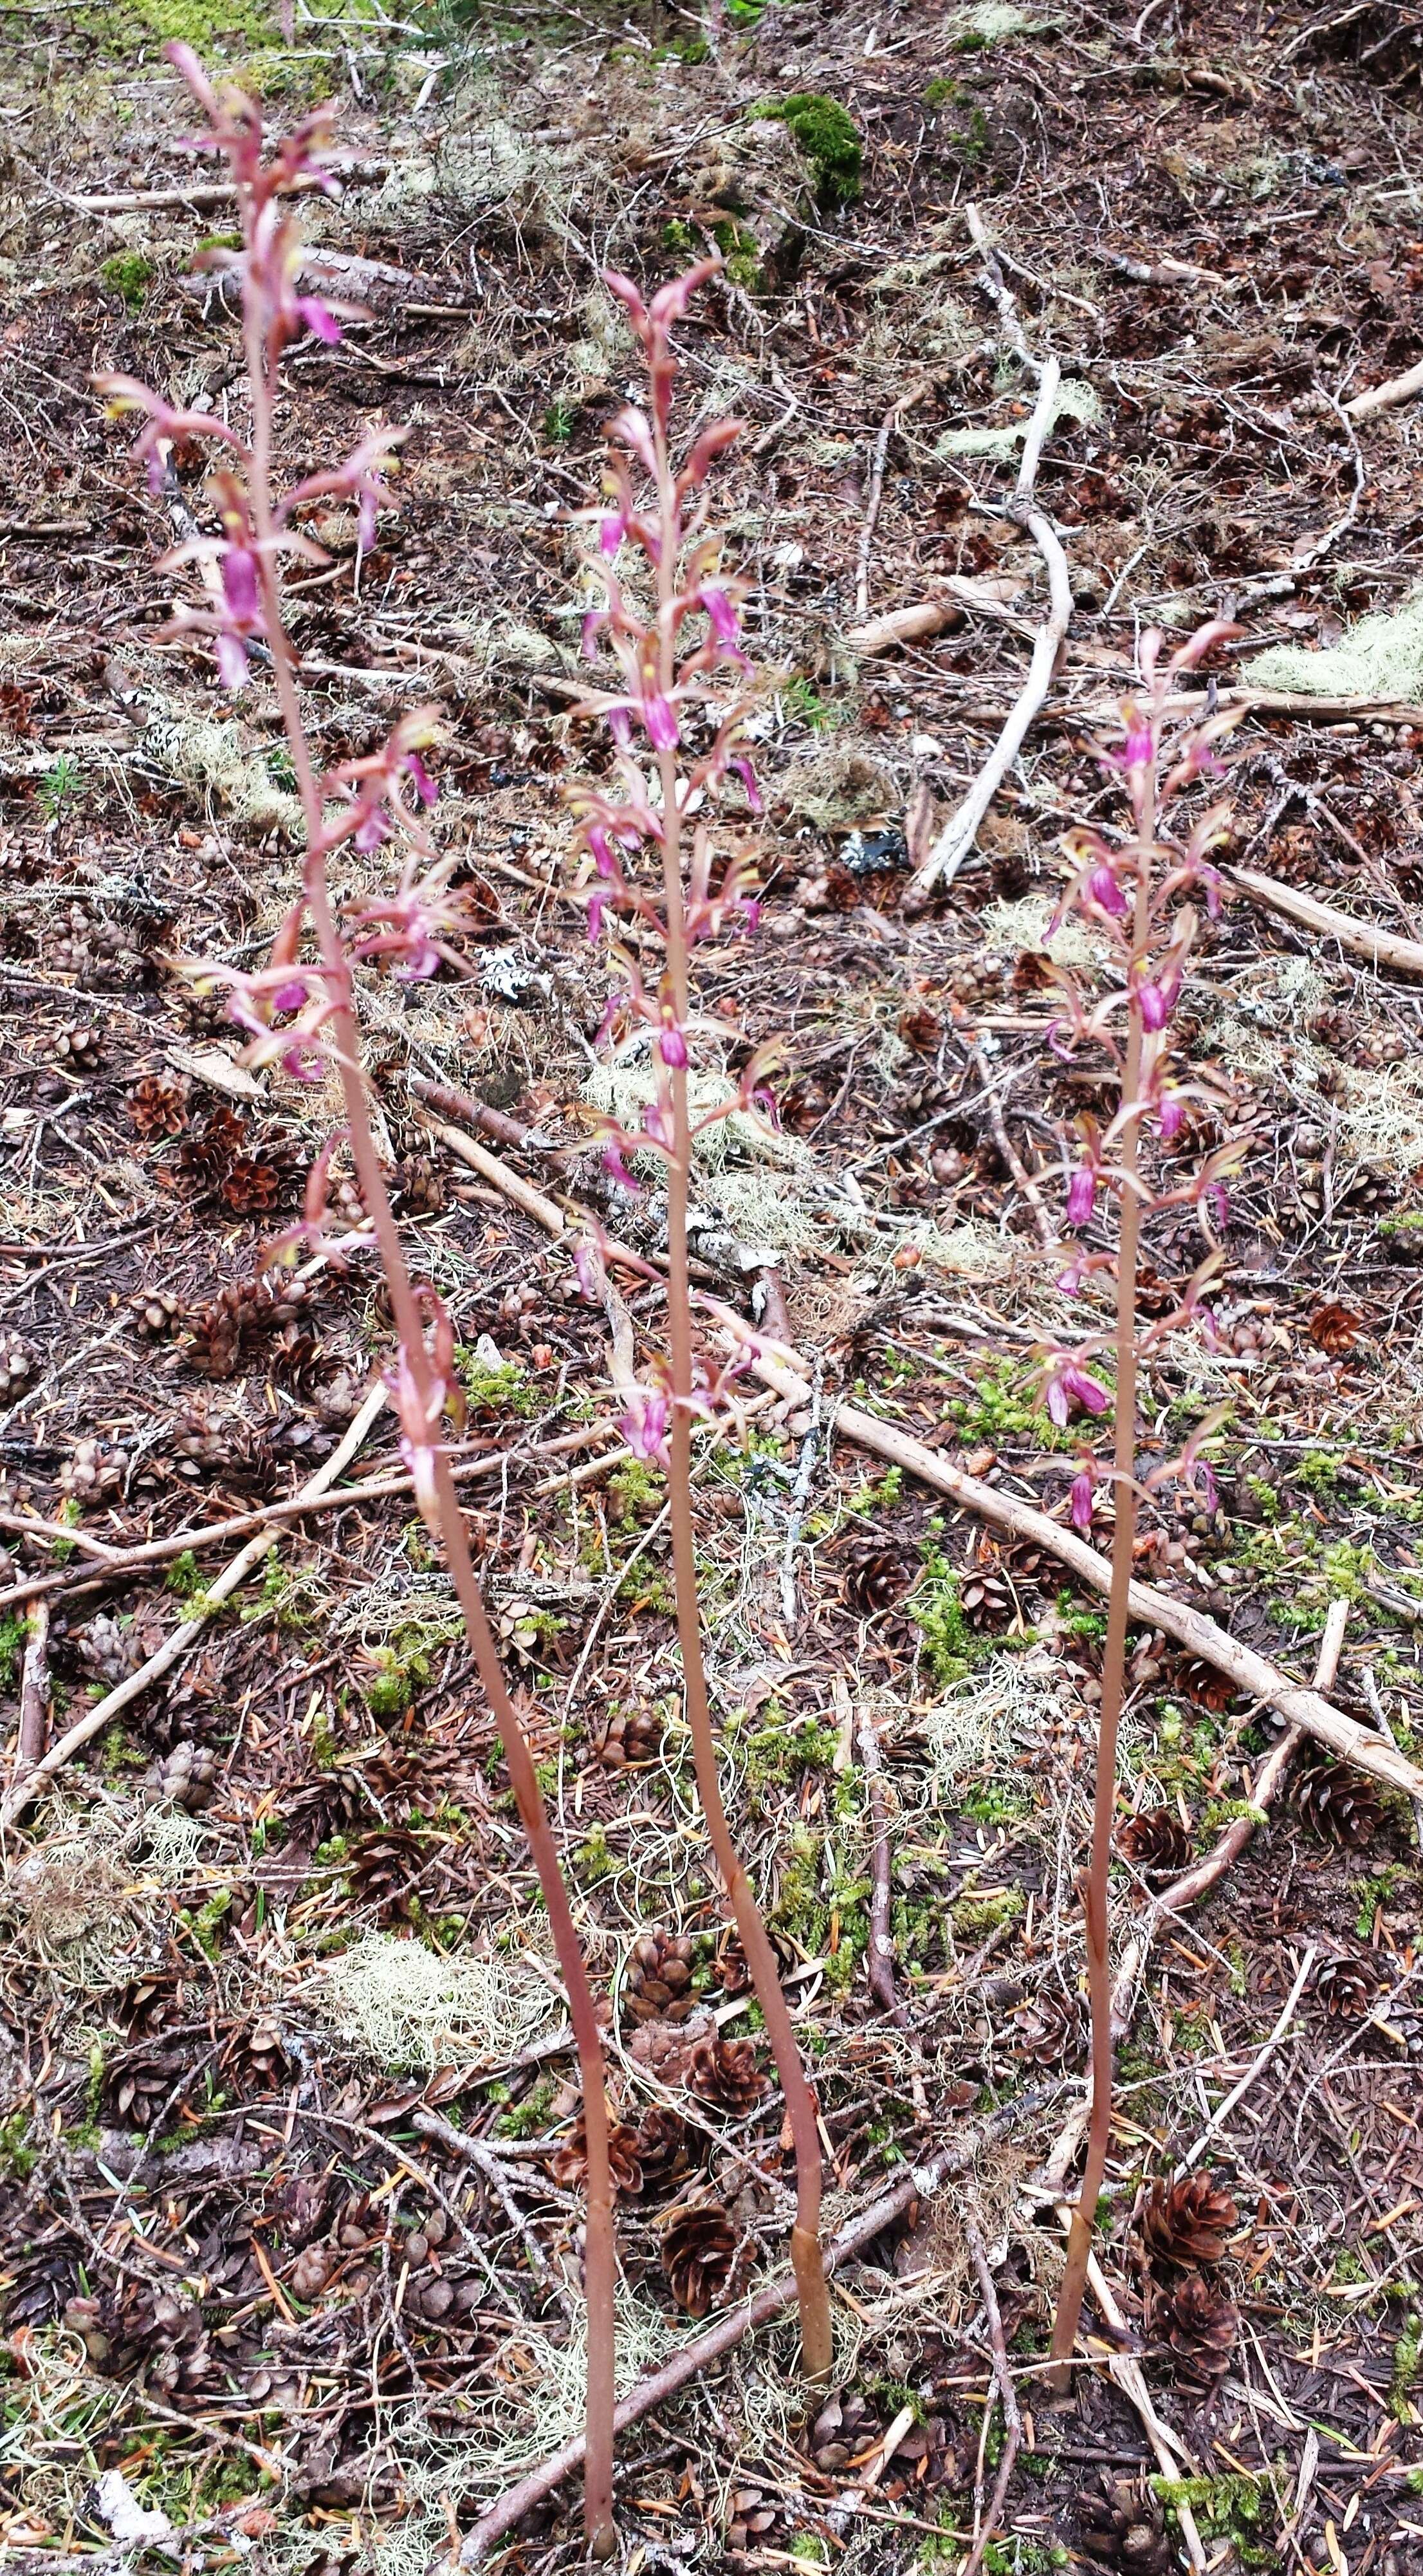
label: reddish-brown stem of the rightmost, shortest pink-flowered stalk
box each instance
[1050,866,1150,2396]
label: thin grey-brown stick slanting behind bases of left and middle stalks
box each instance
[461,2097,1009,2568]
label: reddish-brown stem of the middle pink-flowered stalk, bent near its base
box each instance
[656,438,834,2380]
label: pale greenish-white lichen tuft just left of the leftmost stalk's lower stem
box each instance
[319,1932,561,2068]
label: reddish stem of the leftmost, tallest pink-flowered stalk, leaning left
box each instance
[247,216,618,2558]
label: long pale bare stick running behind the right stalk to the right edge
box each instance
[741,1360,1423,1803]
